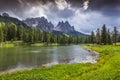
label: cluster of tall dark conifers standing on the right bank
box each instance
[90,24,120,45]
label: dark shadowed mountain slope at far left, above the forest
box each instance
[0,13,28,28]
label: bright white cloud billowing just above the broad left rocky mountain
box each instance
[24,3,53,18]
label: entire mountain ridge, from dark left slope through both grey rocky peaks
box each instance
[0,13,87,36]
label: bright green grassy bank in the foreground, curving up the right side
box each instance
[0,45,120,80]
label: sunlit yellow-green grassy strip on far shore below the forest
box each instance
[0,41,80,48]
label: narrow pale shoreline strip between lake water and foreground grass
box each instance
[0,46,99,75]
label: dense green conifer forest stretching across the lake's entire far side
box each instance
[0,22,120,45]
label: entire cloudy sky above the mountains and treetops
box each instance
[0,0,120,33]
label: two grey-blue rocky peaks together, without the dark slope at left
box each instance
[23,17,86,36]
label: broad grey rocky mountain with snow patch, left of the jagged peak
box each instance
[23,17,54,32]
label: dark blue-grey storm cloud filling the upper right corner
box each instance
[89,0,120,16]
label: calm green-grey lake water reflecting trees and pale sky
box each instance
[0,45,98,72]
